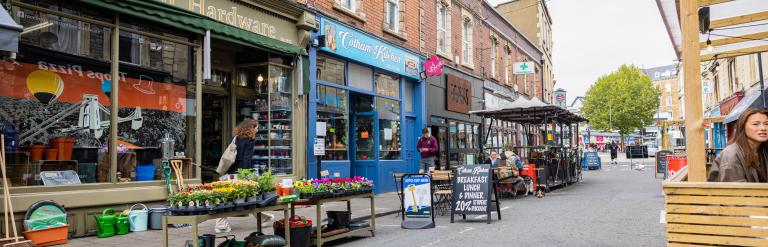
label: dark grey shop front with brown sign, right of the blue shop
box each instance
[427,66,483,169]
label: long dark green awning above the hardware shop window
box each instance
[80,0,306,55]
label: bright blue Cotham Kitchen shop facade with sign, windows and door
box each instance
[307,16,426,193]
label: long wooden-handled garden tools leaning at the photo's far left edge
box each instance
[0,135,35,247]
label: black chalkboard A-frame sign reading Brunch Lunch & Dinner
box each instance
[451,164,501,224]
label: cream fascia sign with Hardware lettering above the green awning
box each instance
[155,0,296,44]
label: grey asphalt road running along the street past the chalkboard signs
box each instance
[329,155,665,246]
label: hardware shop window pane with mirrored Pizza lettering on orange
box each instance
[117,28,197,181]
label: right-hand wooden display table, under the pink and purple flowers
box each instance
[286,192,376,247]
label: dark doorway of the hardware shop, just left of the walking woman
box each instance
[200,93,232,182]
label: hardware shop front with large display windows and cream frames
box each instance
[0,0,314,236]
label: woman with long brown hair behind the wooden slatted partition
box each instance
[707,109,768,183]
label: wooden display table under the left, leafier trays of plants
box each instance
[163,203,293,247]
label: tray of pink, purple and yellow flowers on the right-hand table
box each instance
[293,176,373,200]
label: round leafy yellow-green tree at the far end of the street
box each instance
[582,65,660,142]
